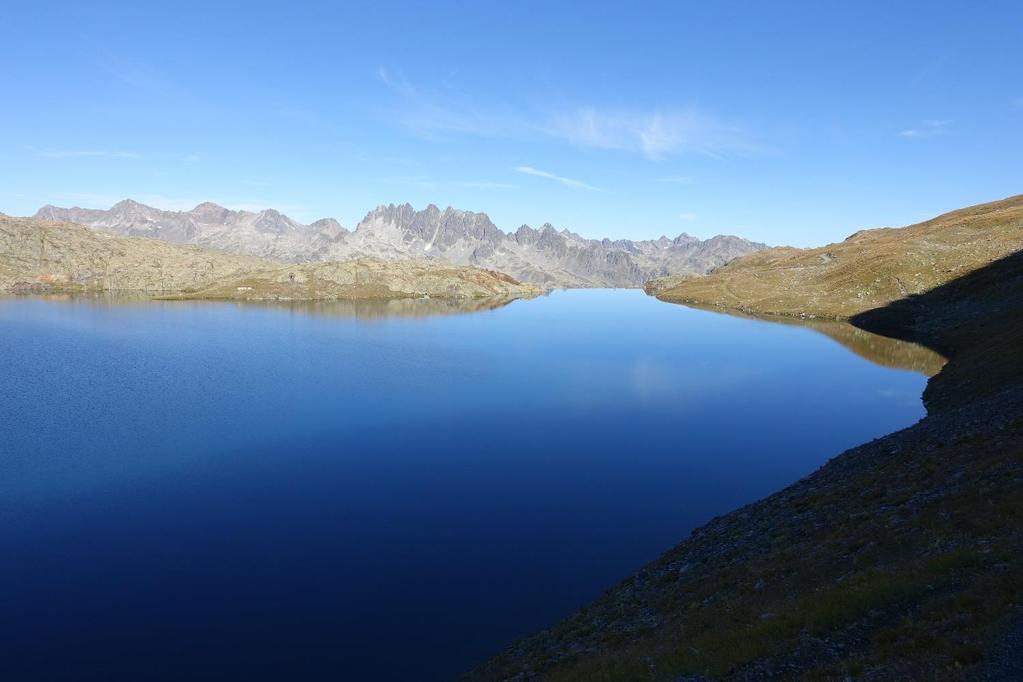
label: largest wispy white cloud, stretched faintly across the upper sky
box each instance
[377,67,765,160]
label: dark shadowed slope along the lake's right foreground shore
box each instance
[470,209,1023,680]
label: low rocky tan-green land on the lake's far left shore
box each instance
[0,217,540,301]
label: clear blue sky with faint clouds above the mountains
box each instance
[0,1,1023,245]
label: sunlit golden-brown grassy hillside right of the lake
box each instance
[648,194,1023,318]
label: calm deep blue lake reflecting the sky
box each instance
[0,290,926,680]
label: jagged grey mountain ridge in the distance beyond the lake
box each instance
[35,199,766,286]
